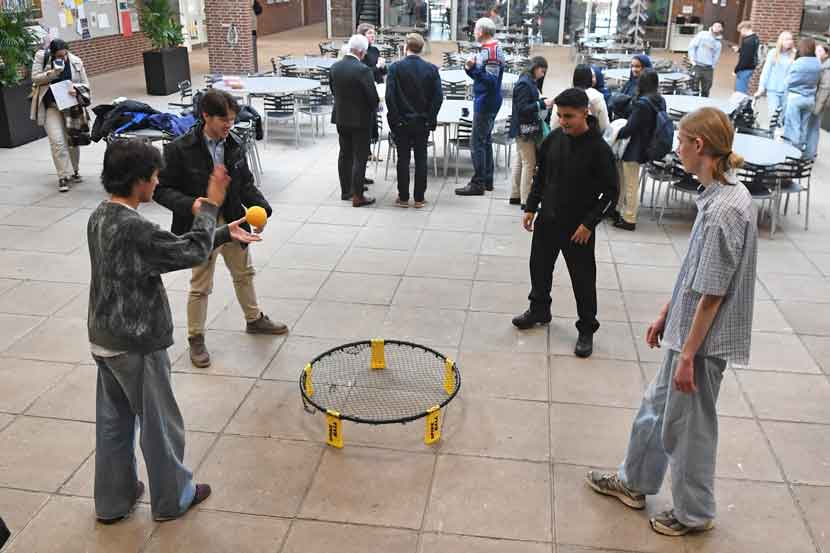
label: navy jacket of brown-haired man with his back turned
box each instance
[386,54,444,129]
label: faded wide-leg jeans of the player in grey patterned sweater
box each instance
[92,350,196,520]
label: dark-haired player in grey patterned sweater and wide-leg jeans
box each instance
[87,137,259,524]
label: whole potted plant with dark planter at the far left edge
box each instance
[0,9,46,148]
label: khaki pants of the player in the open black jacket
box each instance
[187,235,260,337]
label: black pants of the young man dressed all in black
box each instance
[528,216,599,334]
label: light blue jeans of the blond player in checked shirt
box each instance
[619,350,726,527]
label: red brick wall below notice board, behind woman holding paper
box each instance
[69,32,152,75]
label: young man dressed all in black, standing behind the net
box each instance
[513,88,619,357]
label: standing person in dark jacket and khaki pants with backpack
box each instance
[614,69,666,230]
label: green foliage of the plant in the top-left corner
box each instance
[0,9,40,87]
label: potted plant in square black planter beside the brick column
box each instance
[140,0,190,96]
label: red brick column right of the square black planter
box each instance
[205,0,254,74]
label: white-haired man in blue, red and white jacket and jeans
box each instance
[455,17,505,196]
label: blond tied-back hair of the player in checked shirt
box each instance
[679,108,744,183]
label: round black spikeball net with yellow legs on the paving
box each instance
[300,339,461,448]
